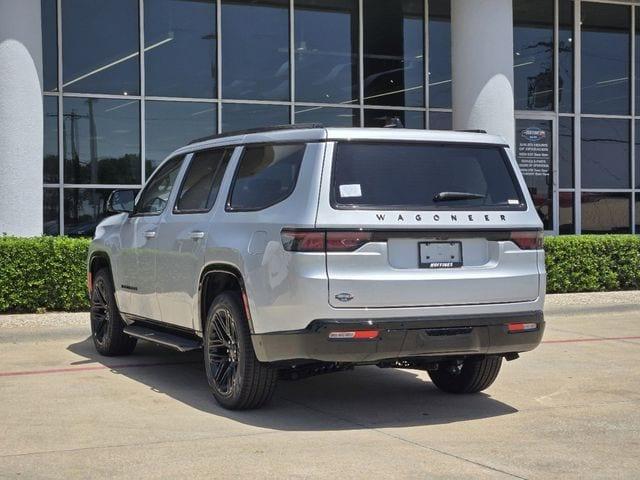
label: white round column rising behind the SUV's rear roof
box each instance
[451,0,515,148]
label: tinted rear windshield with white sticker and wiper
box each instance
[332,142,525,210]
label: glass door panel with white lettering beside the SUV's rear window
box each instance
[516,119,553,230]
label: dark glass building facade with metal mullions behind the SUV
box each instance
[41,0,640,235]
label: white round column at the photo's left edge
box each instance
[0,0,43,236]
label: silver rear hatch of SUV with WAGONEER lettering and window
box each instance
[316,141,541,308]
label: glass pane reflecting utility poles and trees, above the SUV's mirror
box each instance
[63,97,141,184]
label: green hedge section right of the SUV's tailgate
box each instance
[544,235,640,293]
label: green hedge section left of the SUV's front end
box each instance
[0,237,90,312]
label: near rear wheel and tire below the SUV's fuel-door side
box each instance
[203,292,278,410]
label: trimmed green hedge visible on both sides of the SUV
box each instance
[0,235,640,312]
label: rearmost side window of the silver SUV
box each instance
[228,144,306,211]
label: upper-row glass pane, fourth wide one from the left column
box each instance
[294,0,358,103]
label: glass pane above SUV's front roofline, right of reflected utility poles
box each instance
[144,100,217,178]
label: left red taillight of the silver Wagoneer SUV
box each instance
[280,229,373,252]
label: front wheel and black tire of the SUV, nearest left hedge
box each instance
[91,268,136,357]
